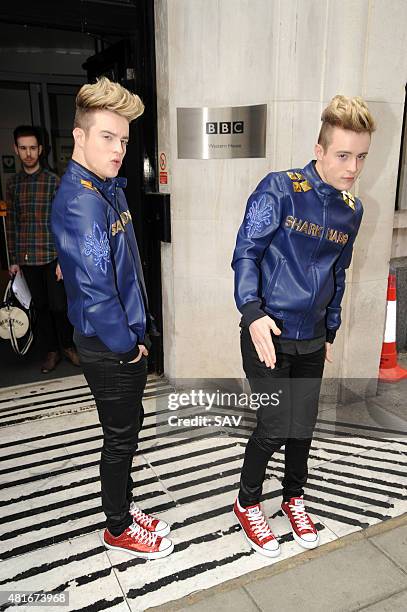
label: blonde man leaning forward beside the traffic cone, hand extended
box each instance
[232,95,376,557]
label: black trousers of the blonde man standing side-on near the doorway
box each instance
[78,347,147,536]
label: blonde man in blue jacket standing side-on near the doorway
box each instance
[52,77,173,559]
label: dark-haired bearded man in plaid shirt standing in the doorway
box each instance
[6,125,79,373]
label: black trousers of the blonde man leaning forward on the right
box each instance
[239,328,325,507]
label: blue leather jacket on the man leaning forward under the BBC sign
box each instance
[232,162,363,342]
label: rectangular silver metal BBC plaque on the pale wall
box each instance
[177,104,267,159]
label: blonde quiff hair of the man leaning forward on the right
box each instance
[318,95,376,151]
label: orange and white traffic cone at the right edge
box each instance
[379,270,407,382]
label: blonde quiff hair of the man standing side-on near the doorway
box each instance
[74,77,144,129]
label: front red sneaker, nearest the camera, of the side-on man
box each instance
[103,523,174,559]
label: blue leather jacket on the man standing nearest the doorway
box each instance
[51,160,146,353]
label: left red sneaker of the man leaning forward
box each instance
[233,499,280,557]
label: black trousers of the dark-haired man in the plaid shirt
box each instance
[22,259,73,353]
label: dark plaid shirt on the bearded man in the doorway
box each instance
[6,168,59,266]
